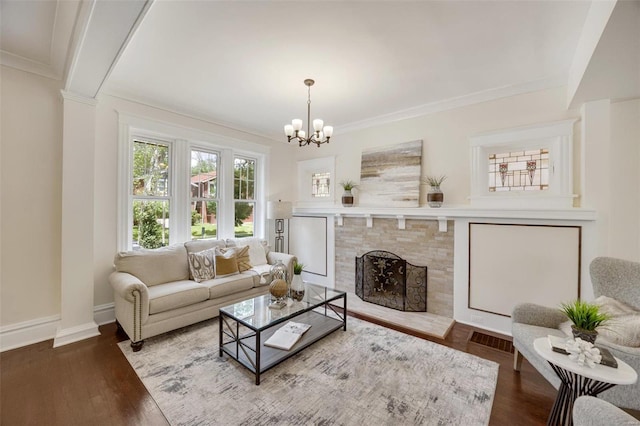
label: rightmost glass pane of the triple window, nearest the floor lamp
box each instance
[233,157,256,237]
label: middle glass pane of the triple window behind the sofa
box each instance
[189,149,218,240]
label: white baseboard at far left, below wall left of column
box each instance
[0,315,60,352]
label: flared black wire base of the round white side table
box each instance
[547,361,615,426]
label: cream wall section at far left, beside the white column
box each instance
[0,66,62,326]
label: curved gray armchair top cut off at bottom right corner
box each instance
[573,396,640,426]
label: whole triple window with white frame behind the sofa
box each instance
[117,113,269,250]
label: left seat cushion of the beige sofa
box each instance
[149,280,209,315]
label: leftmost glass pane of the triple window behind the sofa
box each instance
[131,140,170,248]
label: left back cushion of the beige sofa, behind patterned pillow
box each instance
[114,244,189,287]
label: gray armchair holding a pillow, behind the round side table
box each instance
[511,257,640,410]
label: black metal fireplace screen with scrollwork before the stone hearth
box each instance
[356,250,427,312]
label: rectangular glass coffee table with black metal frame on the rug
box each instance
[219,283,347,385]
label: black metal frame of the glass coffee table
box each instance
[218,292,347,385]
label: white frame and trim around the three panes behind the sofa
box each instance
[116,115,270,251]
